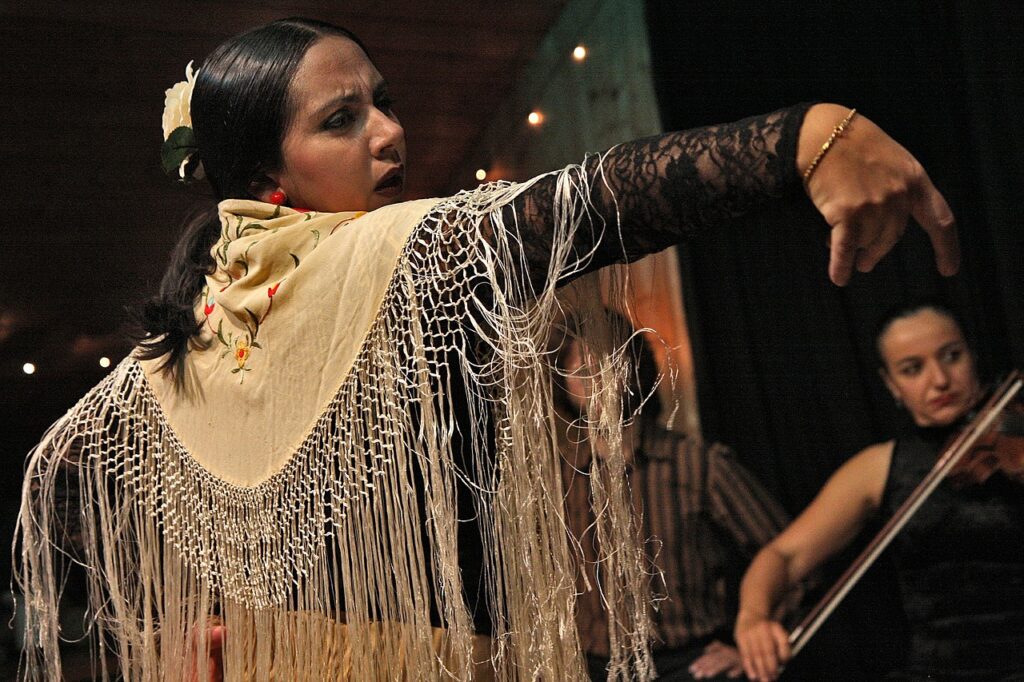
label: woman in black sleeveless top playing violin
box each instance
[735,301,1024,680]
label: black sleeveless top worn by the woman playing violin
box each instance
[882,421,1024,680]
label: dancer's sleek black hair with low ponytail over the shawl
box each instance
[132,17,369,375]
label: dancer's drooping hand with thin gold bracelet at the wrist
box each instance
[797,104,959,286]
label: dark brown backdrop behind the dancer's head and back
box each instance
[0,0,565,680]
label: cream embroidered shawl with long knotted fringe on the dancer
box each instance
[18,167,651,681]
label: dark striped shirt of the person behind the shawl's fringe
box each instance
[562,424,788,655]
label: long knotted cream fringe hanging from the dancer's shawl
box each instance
[17,161,652,681]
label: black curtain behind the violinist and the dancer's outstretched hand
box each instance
[647,0,1024,679]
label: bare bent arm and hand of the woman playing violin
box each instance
[735,441,893,680]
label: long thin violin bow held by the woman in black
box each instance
[790,370,1024,656]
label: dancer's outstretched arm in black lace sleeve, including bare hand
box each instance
[515,104,958,285]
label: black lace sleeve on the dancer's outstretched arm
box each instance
[511,104,810,283]
